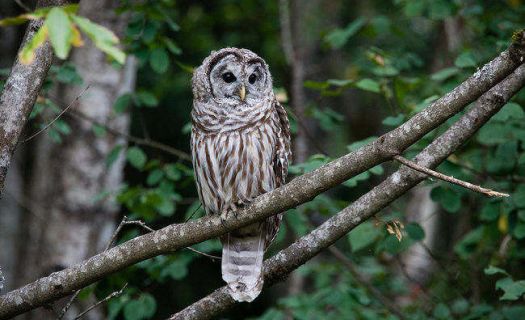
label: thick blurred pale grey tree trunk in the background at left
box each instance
[17,0,136,318]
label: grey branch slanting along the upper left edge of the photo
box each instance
[0,0,68,194]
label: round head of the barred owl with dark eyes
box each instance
[192,48,272,106]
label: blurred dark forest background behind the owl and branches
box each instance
[0,0,525,320]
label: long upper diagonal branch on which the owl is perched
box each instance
[0,32,525,319]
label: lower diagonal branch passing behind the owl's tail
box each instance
[170,65,525,320]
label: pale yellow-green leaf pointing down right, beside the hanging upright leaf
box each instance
[71,15,126,64]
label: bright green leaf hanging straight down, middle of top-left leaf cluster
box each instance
[46,7,73,59]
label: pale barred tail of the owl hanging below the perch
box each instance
[221,223,266,302]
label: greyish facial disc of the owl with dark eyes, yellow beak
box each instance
[209,52,271,105]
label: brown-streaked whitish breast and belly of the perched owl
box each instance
[192,114,279,214]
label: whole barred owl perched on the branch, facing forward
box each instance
[191,48,291,302]
